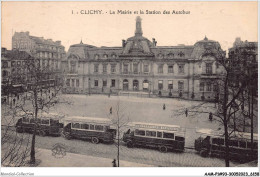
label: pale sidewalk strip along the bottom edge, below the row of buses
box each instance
[36,149,153,167]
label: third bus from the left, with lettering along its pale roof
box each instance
[123,122,185,152]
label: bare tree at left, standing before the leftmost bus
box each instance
[11,57,64,164]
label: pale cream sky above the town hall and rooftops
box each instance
[1,1,258,51]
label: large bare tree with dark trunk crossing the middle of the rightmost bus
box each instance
[176,49,251,167]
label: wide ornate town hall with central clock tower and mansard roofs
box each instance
[62,17,223,99]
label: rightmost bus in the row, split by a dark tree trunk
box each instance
[195,129,258,162]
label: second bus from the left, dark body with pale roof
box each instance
[62,116,117,144]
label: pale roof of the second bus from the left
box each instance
[63,116,112,124]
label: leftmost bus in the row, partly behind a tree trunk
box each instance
[16,113,63,136]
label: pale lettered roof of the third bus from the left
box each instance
[128,122,180,131]
